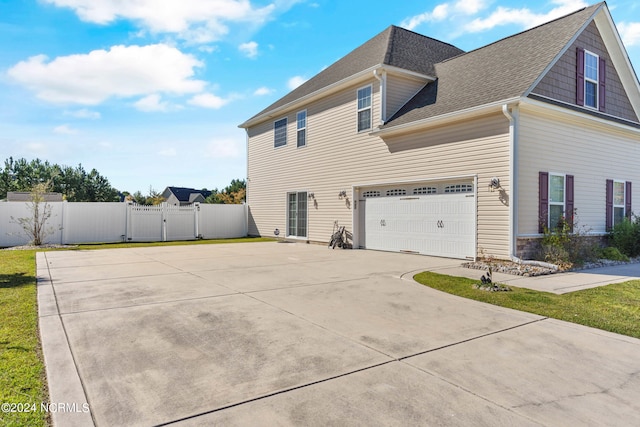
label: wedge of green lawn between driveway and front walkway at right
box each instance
[414,272,640,338]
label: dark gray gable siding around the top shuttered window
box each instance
[532,22,638,122]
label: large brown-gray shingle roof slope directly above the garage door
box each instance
[382,3,604,129]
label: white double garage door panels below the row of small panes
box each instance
[358,186,476,259]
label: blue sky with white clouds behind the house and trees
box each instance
[0,0,640,193]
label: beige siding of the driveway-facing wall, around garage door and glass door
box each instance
[247,78,509,257]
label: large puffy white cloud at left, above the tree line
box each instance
[8,44,206,105]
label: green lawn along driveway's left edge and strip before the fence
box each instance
[0,238,273,427]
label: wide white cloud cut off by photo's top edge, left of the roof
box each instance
[44,0,278,43]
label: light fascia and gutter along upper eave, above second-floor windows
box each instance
[238,64,435,129]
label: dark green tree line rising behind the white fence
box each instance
[0,157,246,205]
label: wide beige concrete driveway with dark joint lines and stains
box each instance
[38,242,640,426]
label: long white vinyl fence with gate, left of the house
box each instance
[0,202,247,247]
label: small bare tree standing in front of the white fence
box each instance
[11,181,55,246]
